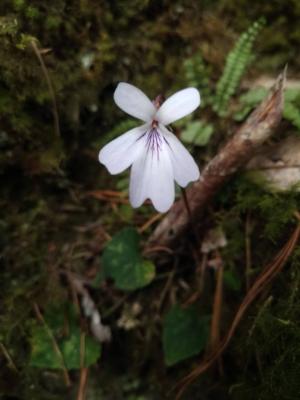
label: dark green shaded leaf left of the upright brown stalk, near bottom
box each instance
[163,304,210,366]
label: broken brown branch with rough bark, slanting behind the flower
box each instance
[149,70,286,246]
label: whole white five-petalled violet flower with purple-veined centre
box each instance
[99,82,200,212]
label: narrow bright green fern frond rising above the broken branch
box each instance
[213,18,265,115]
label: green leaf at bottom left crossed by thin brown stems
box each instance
[30,305,101,369]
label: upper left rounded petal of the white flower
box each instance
[114,82,156,122]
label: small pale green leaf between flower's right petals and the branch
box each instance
[180,121,214,146]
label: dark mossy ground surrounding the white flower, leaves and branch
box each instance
[0,0,300,400]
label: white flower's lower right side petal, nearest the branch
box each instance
[159,125,200,187]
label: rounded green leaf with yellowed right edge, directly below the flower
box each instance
[102,228,155,290]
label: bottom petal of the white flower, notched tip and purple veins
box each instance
[129,134,175,212]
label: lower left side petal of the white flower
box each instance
[99,124,149,175]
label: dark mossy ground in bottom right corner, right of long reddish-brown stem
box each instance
[232,266,300,400]
